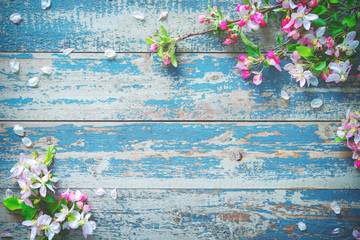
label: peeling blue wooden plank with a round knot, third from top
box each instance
[0,122,360,189]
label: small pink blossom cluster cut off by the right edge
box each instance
[336,110,360,168]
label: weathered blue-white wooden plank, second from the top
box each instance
[0,54,360,121]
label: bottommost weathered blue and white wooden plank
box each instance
[0,189,360,239]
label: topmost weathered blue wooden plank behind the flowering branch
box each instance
[0,0,281,52]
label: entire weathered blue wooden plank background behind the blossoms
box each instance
[0,0,360,239]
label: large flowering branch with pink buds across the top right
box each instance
[146,0,360,87]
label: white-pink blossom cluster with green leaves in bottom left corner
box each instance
[3,146,96,240]
